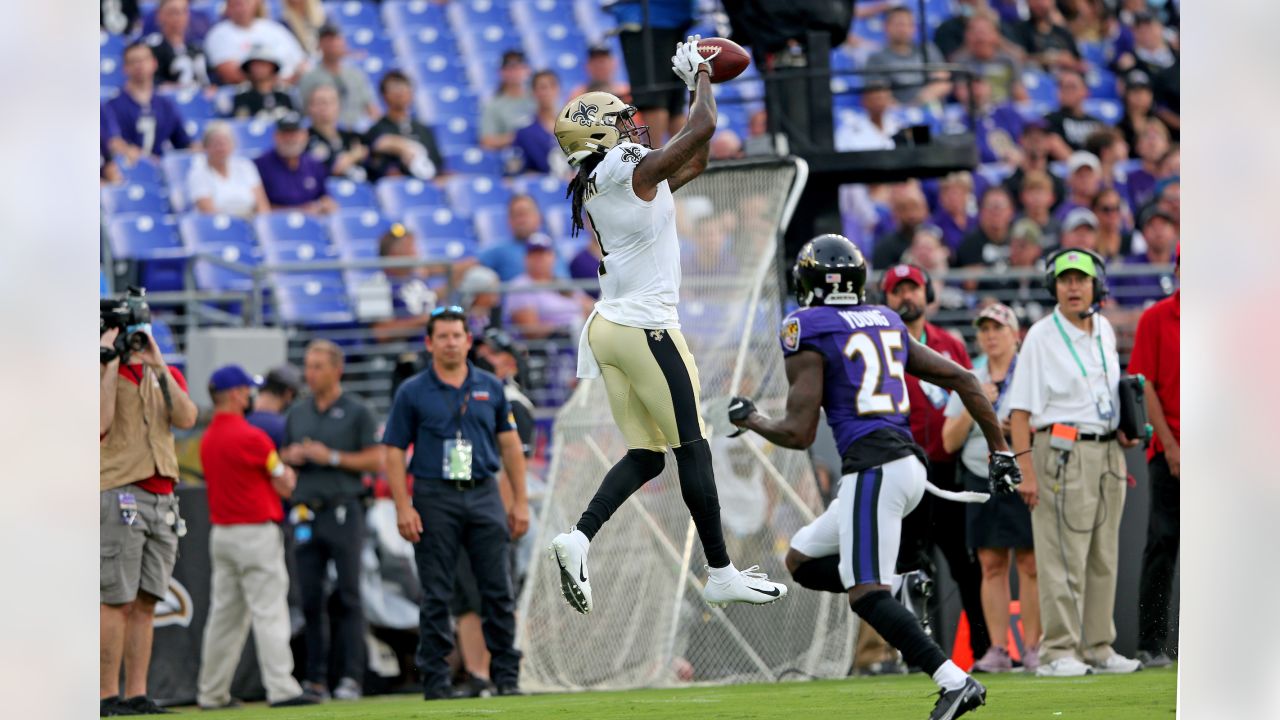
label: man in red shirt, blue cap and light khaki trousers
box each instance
[196,365,320,710]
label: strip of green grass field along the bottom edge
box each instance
[187,669,1178,720]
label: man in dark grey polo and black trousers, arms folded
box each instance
[280,340,383,700]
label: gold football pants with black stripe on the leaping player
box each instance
[586,314,707,452]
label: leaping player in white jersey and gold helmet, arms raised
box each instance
[550,36,787,614]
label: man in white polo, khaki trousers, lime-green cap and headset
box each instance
[1006,244,1142,678]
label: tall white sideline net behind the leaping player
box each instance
[517,160,856,691]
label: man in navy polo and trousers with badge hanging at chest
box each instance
[383,306,529,700]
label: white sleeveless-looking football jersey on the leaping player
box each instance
[584,142,680,329]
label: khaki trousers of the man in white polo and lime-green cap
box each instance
[1032,432,1126,662]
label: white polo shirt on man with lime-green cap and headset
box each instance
[1007,302,1123,434]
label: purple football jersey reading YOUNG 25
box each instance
[781,305,911,455]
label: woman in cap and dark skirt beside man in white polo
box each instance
[942,302,1039,673]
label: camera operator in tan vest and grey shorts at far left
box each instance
[99,293,197,716]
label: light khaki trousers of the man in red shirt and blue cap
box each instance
[197,523,302,707]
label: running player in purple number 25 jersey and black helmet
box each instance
[730,234,1021,720]
